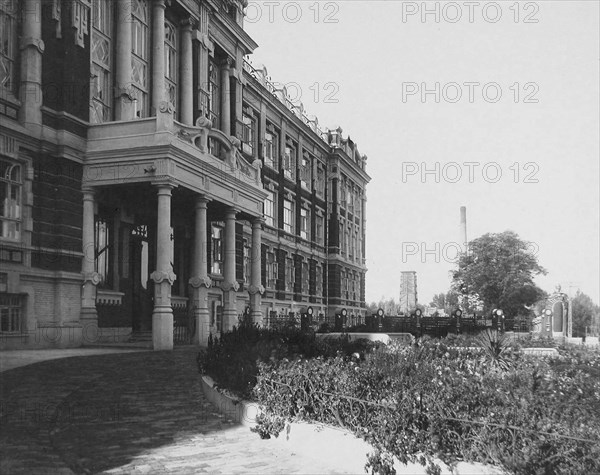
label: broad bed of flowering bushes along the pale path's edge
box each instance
[254,340,600,474]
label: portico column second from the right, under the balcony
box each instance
[221,208,240,331]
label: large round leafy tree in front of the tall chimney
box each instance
[452,231,546,317]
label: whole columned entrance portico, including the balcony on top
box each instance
[82,103,265,350]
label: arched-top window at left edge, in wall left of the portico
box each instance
[0,160,23,241]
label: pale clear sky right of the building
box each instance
[245,0,600,304]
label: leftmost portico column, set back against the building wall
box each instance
[80,188,100,335]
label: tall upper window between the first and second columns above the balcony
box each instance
[131,0,150,118]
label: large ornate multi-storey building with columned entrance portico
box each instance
[0,0,369,349]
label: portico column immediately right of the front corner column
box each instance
[190,196,212,346]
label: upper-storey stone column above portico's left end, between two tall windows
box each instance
[115,0,133,120]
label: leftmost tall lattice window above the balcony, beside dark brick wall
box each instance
[90,0,113,124]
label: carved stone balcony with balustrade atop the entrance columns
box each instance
[83,103,265,215]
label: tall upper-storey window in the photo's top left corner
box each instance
[0,0,19,96]
